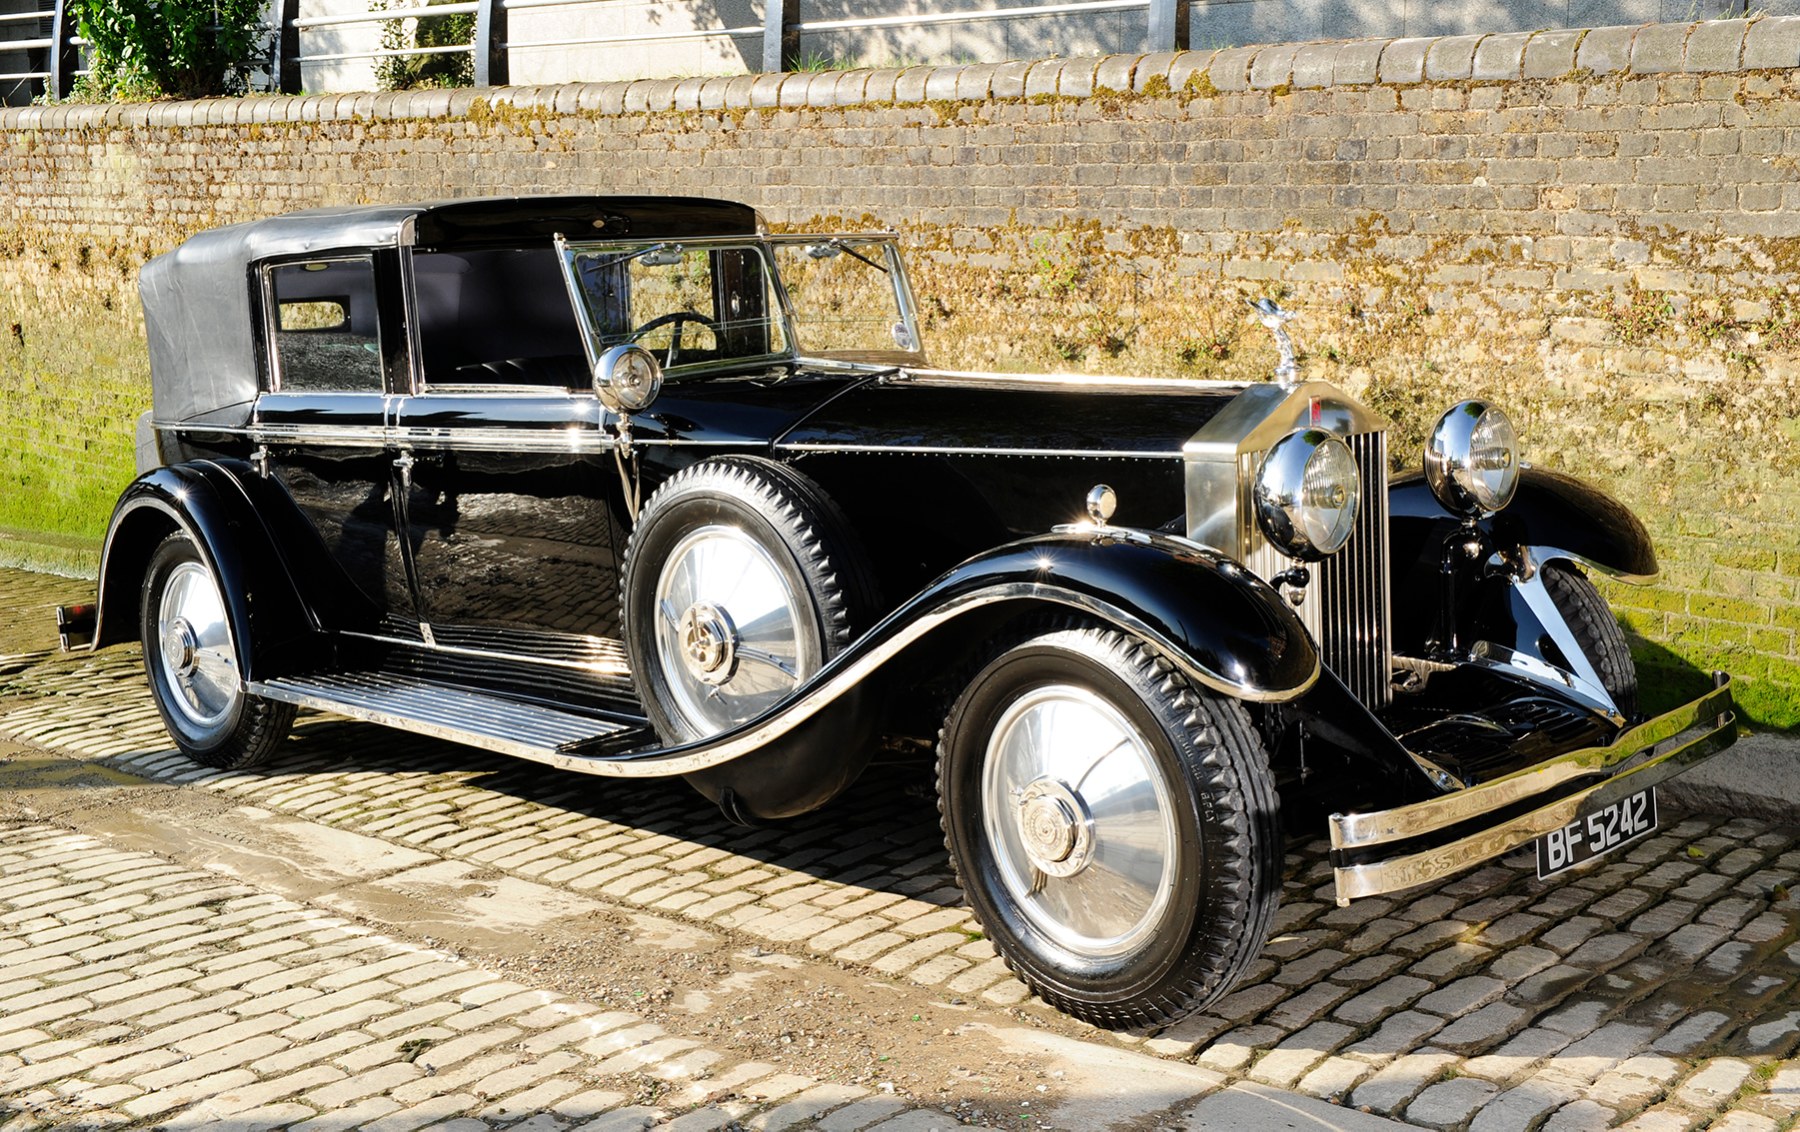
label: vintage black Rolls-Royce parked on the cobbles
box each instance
[58,198,1733,1026]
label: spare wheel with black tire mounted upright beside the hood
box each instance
[621,455,875,743]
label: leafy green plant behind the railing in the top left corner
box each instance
[76,0,270,101]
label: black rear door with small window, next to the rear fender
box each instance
[252,252,414,628]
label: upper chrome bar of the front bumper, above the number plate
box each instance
[1330,677,1735,849]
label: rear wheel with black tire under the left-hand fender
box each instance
[139,533,293,770]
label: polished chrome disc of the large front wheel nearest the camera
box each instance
[981,684,1177,959]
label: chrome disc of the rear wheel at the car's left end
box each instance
[157,562,243,729]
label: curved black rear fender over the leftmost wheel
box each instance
[94,461,324,680]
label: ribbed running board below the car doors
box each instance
[248,671,668,766]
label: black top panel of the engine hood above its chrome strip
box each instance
[776,369,1246,461]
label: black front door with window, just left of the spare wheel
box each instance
[394,247,630,695]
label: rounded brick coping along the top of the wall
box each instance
[0,16,1800,130]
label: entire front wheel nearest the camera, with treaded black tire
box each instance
[938,628,1282,1028]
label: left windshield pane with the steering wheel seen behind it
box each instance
[563,243,790,371]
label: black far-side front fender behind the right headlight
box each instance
[1388,468,1658,585]
